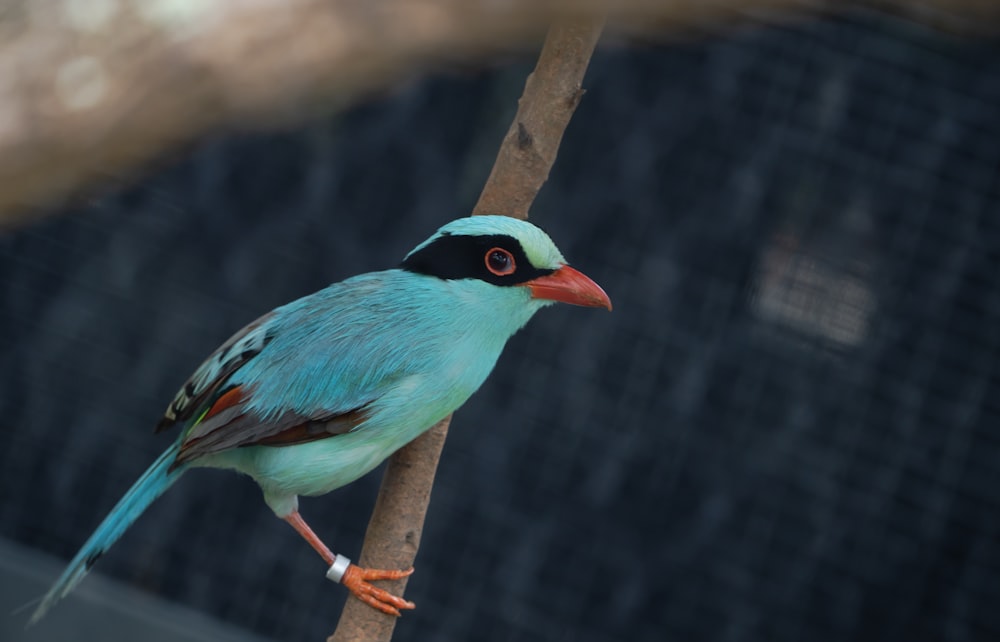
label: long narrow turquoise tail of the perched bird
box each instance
[28,445,184,626]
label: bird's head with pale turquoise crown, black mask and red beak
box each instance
[401,216,611,310]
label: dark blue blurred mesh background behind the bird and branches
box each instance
[0,5,1000,642]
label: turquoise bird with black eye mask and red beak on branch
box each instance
[29,215,612,625]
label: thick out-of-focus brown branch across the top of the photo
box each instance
[0,0,1000,225]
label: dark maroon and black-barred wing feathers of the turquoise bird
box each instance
[156,304,374,467]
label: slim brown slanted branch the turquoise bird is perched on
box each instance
[328,13,603,642]
